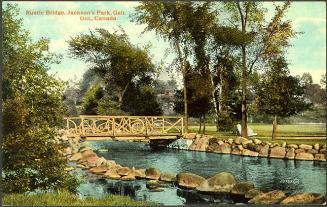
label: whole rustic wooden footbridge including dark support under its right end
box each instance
[64,115,184,148]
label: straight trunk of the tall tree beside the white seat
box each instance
[241,46,248,138]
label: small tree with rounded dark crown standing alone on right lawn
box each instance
[256,57,310,139]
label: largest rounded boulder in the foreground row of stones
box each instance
[196,172,236,192]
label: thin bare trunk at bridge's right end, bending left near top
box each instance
[176,41,188,133]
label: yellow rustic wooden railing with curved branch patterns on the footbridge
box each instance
[64,115,184,137]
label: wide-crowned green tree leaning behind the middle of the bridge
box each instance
[68,29,154,107]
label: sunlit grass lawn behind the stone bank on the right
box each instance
[189,124,326,144]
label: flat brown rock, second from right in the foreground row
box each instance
[249,190,286,204]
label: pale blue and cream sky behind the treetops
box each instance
[3,1,326,83]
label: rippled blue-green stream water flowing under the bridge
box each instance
[76,141,326,205]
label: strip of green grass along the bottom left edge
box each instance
[3,192,156,206]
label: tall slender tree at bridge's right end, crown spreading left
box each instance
[133,2,191,132]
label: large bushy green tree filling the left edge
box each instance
[2,4,78,193]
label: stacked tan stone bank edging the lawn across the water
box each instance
[168,133,326,161]
